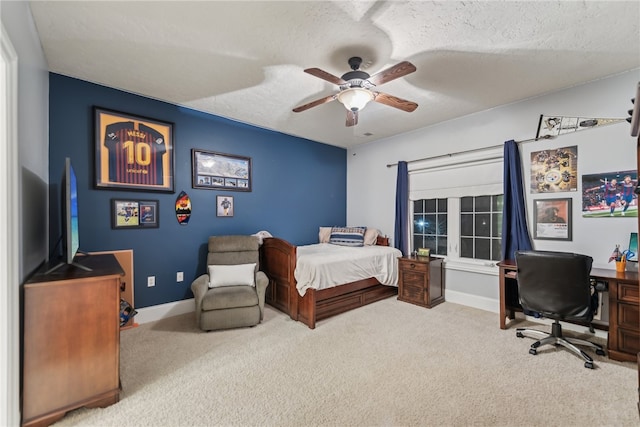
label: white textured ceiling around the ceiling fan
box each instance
[30,0,640,148]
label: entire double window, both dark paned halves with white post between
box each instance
[413,194,502,261]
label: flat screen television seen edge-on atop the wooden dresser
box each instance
[47,157,91,273]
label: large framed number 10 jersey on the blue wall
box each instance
[93,107,174,193]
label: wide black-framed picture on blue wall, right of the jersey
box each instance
[191,149,251,191]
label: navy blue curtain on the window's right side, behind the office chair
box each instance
[502,140,531,259]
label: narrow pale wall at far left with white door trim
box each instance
[0,1,49,425]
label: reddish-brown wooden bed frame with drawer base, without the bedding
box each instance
[260,236,398,329]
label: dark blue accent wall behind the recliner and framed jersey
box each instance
[49,73,347,308]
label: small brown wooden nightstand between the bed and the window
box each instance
[398,257,444,308]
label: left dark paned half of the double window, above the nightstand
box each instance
[413,199,448,255]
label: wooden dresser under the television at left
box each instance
[22,255,124,426]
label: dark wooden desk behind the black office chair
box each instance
[498,260,640,361]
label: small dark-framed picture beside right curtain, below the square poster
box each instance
[533,198,572,240]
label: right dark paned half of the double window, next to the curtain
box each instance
[460,195,502,261]
